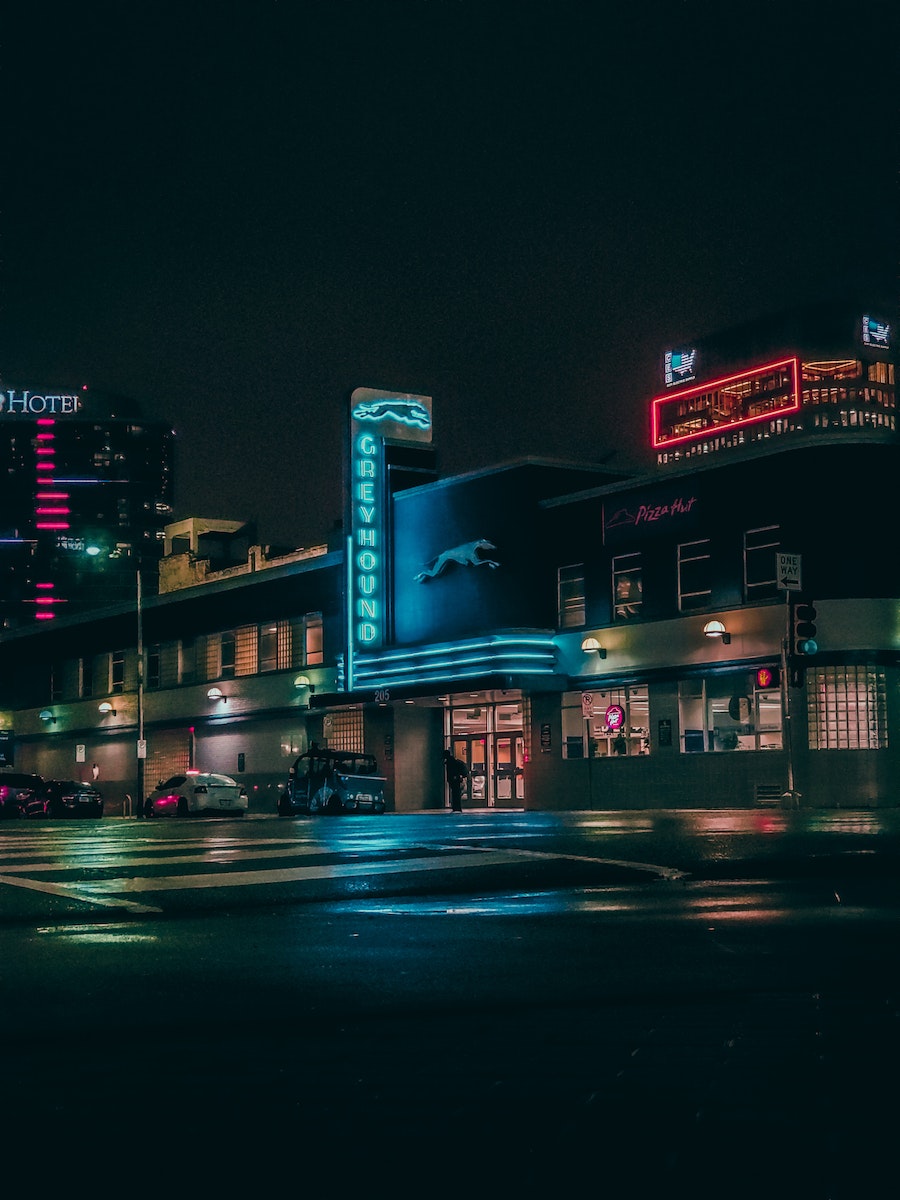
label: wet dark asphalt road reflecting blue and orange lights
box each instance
[0,811,900,1200]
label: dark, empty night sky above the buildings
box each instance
[0,0,900,546]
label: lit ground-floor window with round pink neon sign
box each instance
[562,685,650,758]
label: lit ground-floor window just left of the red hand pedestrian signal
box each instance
[678,671,782,754]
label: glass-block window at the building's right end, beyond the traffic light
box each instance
[806,666,888,750]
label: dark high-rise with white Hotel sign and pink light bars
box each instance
[0,383,173,629]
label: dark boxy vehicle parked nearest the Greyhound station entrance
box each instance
[278,748,385,817]
